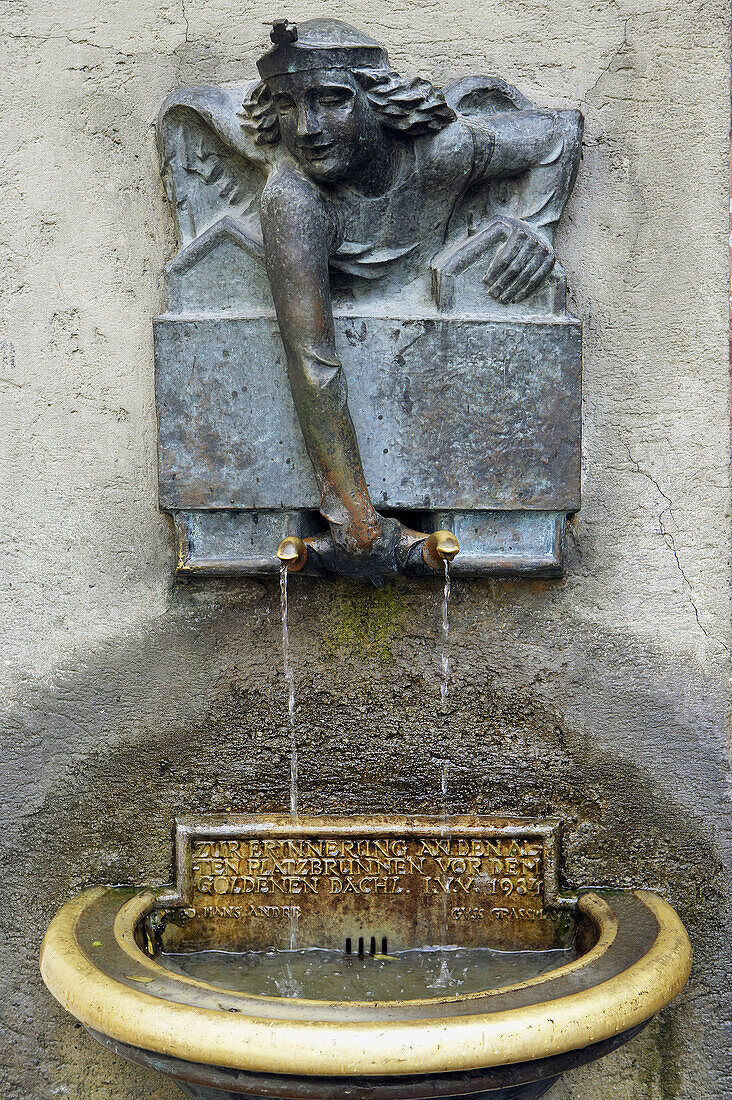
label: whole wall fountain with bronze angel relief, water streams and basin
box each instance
[41,20,690,1100]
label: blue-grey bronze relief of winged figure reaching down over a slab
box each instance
[156,20,582,583]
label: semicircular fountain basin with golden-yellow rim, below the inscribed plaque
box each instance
[41,818,691,1100]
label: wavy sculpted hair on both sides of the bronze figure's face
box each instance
[239,68,456,145]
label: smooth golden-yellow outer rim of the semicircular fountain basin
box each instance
[41,887,691,1077]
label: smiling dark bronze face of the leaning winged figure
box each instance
[267,69,383,183]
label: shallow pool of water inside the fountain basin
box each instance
[157,947,577,1001]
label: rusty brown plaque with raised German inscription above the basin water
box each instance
[156,816,572,952]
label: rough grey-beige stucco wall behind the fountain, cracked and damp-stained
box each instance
[0,0,732,1100]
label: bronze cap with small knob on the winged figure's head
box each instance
[256,19,389,80]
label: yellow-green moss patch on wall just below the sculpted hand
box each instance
[323,581,404,663]
